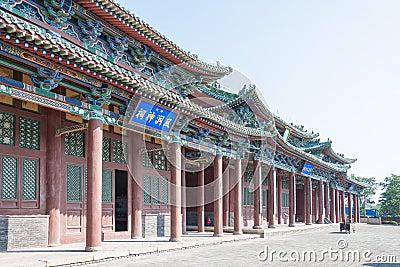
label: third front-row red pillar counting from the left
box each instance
[214,154,223,237]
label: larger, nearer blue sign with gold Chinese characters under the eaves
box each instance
[132,101,177,132]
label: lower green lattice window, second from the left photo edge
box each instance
[22,158,39,200]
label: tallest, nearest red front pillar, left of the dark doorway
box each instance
[85,119,103,251]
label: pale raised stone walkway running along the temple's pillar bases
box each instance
[0,224,338,267]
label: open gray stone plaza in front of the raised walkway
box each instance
[90,224,400,267]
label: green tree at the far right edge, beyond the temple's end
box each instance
[379,174,400,219]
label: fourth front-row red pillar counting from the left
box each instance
[232,159,243,235]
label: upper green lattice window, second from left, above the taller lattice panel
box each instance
[19,117,40,150]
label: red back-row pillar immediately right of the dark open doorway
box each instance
[128,131,144,239]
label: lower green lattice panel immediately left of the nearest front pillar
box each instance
[67,165,82,202]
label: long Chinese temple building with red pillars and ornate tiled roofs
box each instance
[0,0,365,251]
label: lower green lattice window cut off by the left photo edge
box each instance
[1,156,18,200]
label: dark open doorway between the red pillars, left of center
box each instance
[115,170,128,232]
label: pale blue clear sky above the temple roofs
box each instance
[120,0,400,195]
